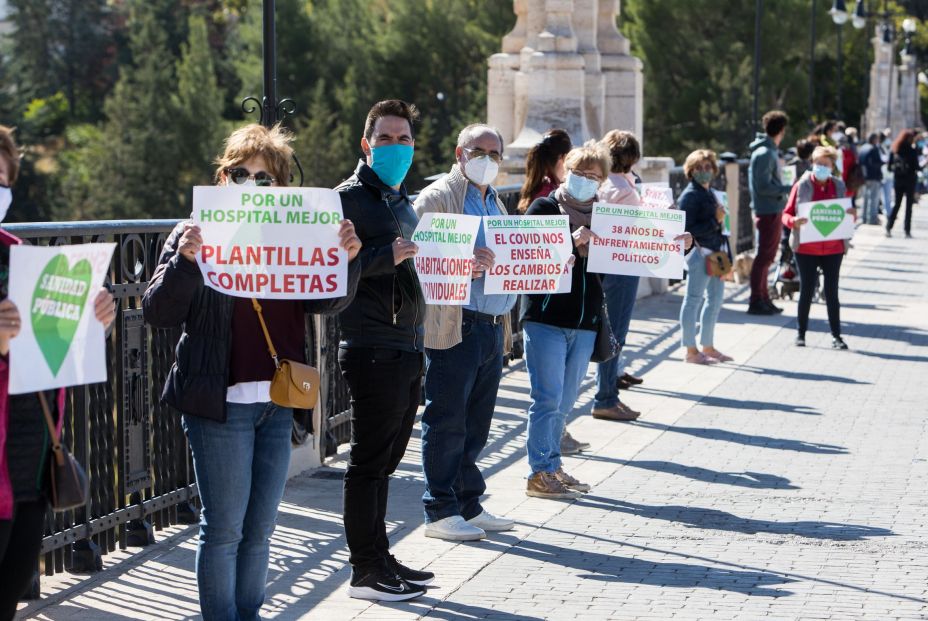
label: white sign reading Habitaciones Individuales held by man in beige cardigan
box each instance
[412,213,480,306]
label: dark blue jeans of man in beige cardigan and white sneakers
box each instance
[422,318,503,522]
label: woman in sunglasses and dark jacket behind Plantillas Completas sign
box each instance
[142,124,361,621]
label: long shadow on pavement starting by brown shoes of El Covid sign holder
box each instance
[577,494,895,541]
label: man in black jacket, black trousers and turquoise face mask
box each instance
[335,99,434,601]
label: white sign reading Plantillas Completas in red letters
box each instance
[193,186,348,300]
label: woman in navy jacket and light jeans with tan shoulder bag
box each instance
[677,149,732,365]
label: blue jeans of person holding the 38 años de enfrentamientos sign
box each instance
[593,274,638,408]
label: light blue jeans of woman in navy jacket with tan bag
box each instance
[680,248,725,347]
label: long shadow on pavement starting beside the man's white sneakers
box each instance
[482,540,795,597]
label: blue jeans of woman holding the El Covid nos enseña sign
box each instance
[522,321,596,474]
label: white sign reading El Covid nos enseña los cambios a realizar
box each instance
[483,216,573,293]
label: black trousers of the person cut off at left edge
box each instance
[0,498,48,621]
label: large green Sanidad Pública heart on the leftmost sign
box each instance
[30,254,93,375]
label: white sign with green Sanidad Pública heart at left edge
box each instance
[9,244,116,395]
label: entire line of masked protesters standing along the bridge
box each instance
[0,100,922,621]
